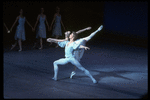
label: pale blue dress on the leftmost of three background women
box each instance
[14,17,26,41]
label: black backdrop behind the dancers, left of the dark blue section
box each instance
[3,1,104,45]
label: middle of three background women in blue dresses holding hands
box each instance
[33,8,49,49]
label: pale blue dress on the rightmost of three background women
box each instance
[52,15,62,36]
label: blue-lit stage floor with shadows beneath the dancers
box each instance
[3,43,148,99]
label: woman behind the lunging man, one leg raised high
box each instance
[47,25,103,78]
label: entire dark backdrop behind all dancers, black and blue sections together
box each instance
[3,1,148,46]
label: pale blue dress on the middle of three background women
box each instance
[36,16,46,38]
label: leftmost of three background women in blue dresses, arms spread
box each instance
[10,9,33,51]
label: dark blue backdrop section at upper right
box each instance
[104,2,148,38]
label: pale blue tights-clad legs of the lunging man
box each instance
[53,58,97,83]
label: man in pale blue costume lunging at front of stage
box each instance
[47,32,97,83]
